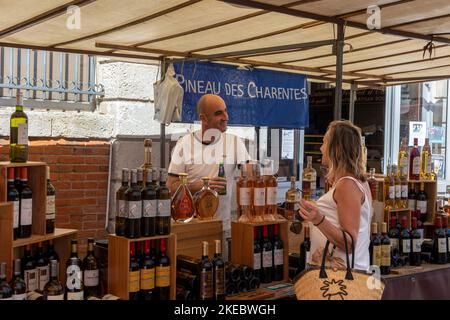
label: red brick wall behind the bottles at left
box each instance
[0,139,110,257]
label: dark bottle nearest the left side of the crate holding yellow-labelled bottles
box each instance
[83,238,100,299]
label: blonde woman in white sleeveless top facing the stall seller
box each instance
[299,120,372,271]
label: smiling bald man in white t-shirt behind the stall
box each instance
[167,94,250,257]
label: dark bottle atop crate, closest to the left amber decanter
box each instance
[156,169,171,235]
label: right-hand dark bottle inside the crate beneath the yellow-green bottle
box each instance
[19,167,33,238]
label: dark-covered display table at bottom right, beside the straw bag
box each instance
[382,264,450,300]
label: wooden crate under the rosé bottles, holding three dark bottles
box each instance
[231,220,289,281]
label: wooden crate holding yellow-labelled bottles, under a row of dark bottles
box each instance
[108,233,177,300]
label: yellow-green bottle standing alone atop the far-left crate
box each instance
[9,90,28,162]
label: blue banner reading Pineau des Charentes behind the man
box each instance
[174,62,309,129]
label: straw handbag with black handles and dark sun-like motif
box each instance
[294,231,384,300]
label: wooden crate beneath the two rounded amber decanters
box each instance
[171,219,224,258]
